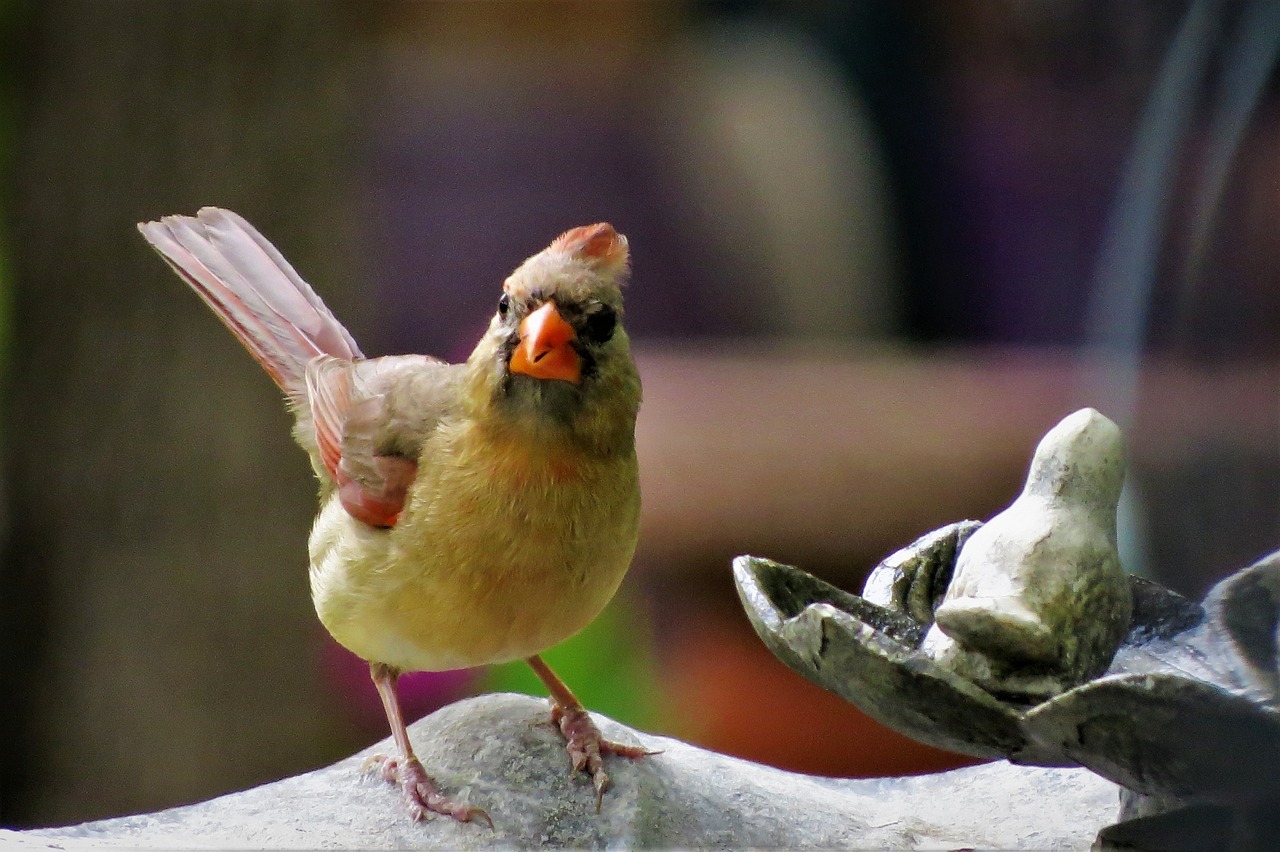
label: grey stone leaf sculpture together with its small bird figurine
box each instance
[733,411,1280,848]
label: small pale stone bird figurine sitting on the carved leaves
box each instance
[920,408,1133,698]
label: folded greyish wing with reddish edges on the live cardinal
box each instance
[306,356,461,527]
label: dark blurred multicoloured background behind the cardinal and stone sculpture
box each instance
[0,0,1280,826]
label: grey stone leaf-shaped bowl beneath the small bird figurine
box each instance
[733,537,1280,823]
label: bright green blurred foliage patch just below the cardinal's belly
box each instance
[481,591,663,729]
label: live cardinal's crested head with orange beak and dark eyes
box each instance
[468,223,640,449]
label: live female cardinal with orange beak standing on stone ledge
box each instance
[138,207,652,825]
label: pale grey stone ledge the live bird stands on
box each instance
[0,695,1119,849]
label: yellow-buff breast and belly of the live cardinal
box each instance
[300,421,640,670]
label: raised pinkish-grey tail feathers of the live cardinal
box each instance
[138,207,362,402]
